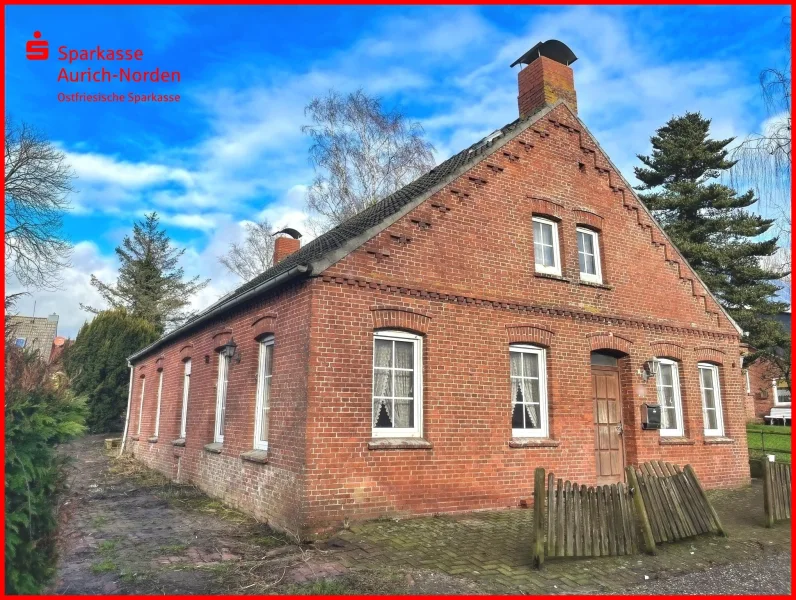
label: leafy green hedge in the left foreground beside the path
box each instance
[5,342,85,594]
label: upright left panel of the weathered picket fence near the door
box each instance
[534,468,638,566]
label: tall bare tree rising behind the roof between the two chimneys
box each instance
[301,90,434,233]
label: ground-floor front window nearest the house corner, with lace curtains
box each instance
[373,331,423,437]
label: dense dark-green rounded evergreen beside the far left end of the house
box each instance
[64,309,159,433]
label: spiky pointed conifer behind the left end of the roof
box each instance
[83,212,210,333]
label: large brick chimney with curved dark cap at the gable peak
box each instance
[511,40,578,117]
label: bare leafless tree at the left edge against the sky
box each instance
[5,119,74,289]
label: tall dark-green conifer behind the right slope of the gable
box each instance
[635,112,790,366]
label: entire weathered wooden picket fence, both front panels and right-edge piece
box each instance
[533,461,728,567]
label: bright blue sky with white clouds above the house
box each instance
[6,6,790,335]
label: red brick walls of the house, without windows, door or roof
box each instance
[127,52,749,532]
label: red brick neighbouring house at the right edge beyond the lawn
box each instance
[744,311,791,423]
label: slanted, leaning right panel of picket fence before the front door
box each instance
[628,460,725,543]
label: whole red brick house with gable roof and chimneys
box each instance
[126,40,749,534]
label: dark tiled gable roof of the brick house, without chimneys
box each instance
[129,100,742,360]
